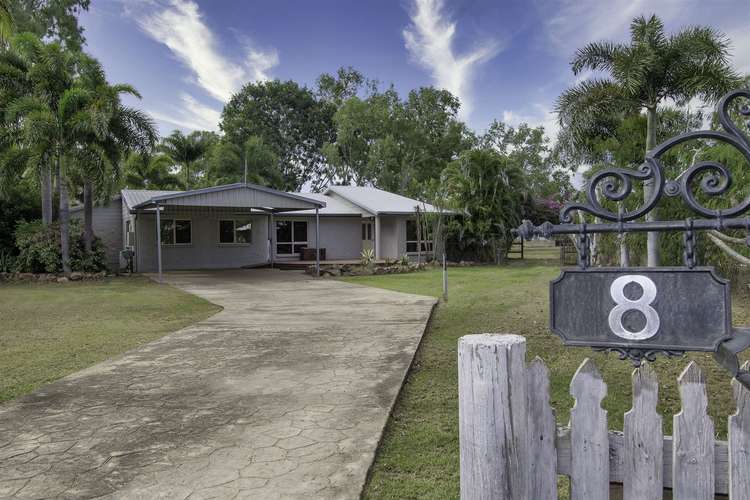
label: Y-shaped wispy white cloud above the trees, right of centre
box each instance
[403,0,501,118]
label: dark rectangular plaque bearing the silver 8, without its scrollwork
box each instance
[550,268,731,353]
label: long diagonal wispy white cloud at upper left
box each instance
[133,0,279,130]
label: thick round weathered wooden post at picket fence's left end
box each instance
[458,334,529,500]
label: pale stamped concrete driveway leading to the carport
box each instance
[0,269,435,500]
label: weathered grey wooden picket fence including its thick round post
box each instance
[458,335,750,500]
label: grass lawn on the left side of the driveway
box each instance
[0,277,220,402]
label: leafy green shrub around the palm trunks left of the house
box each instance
[15,219,107,273]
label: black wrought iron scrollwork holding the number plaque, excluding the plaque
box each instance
[515,89,750,388]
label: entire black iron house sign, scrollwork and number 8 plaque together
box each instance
[515,89,750,388]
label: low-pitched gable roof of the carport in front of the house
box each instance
[128,183,326,211]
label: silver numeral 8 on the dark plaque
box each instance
[609,274,659,340]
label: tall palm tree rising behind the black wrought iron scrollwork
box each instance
[556,15,741,266]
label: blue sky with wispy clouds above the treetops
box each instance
[81,0,750,141]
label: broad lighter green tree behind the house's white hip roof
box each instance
[323,87,474,196]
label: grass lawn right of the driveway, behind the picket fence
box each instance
[347,256,750,499]
